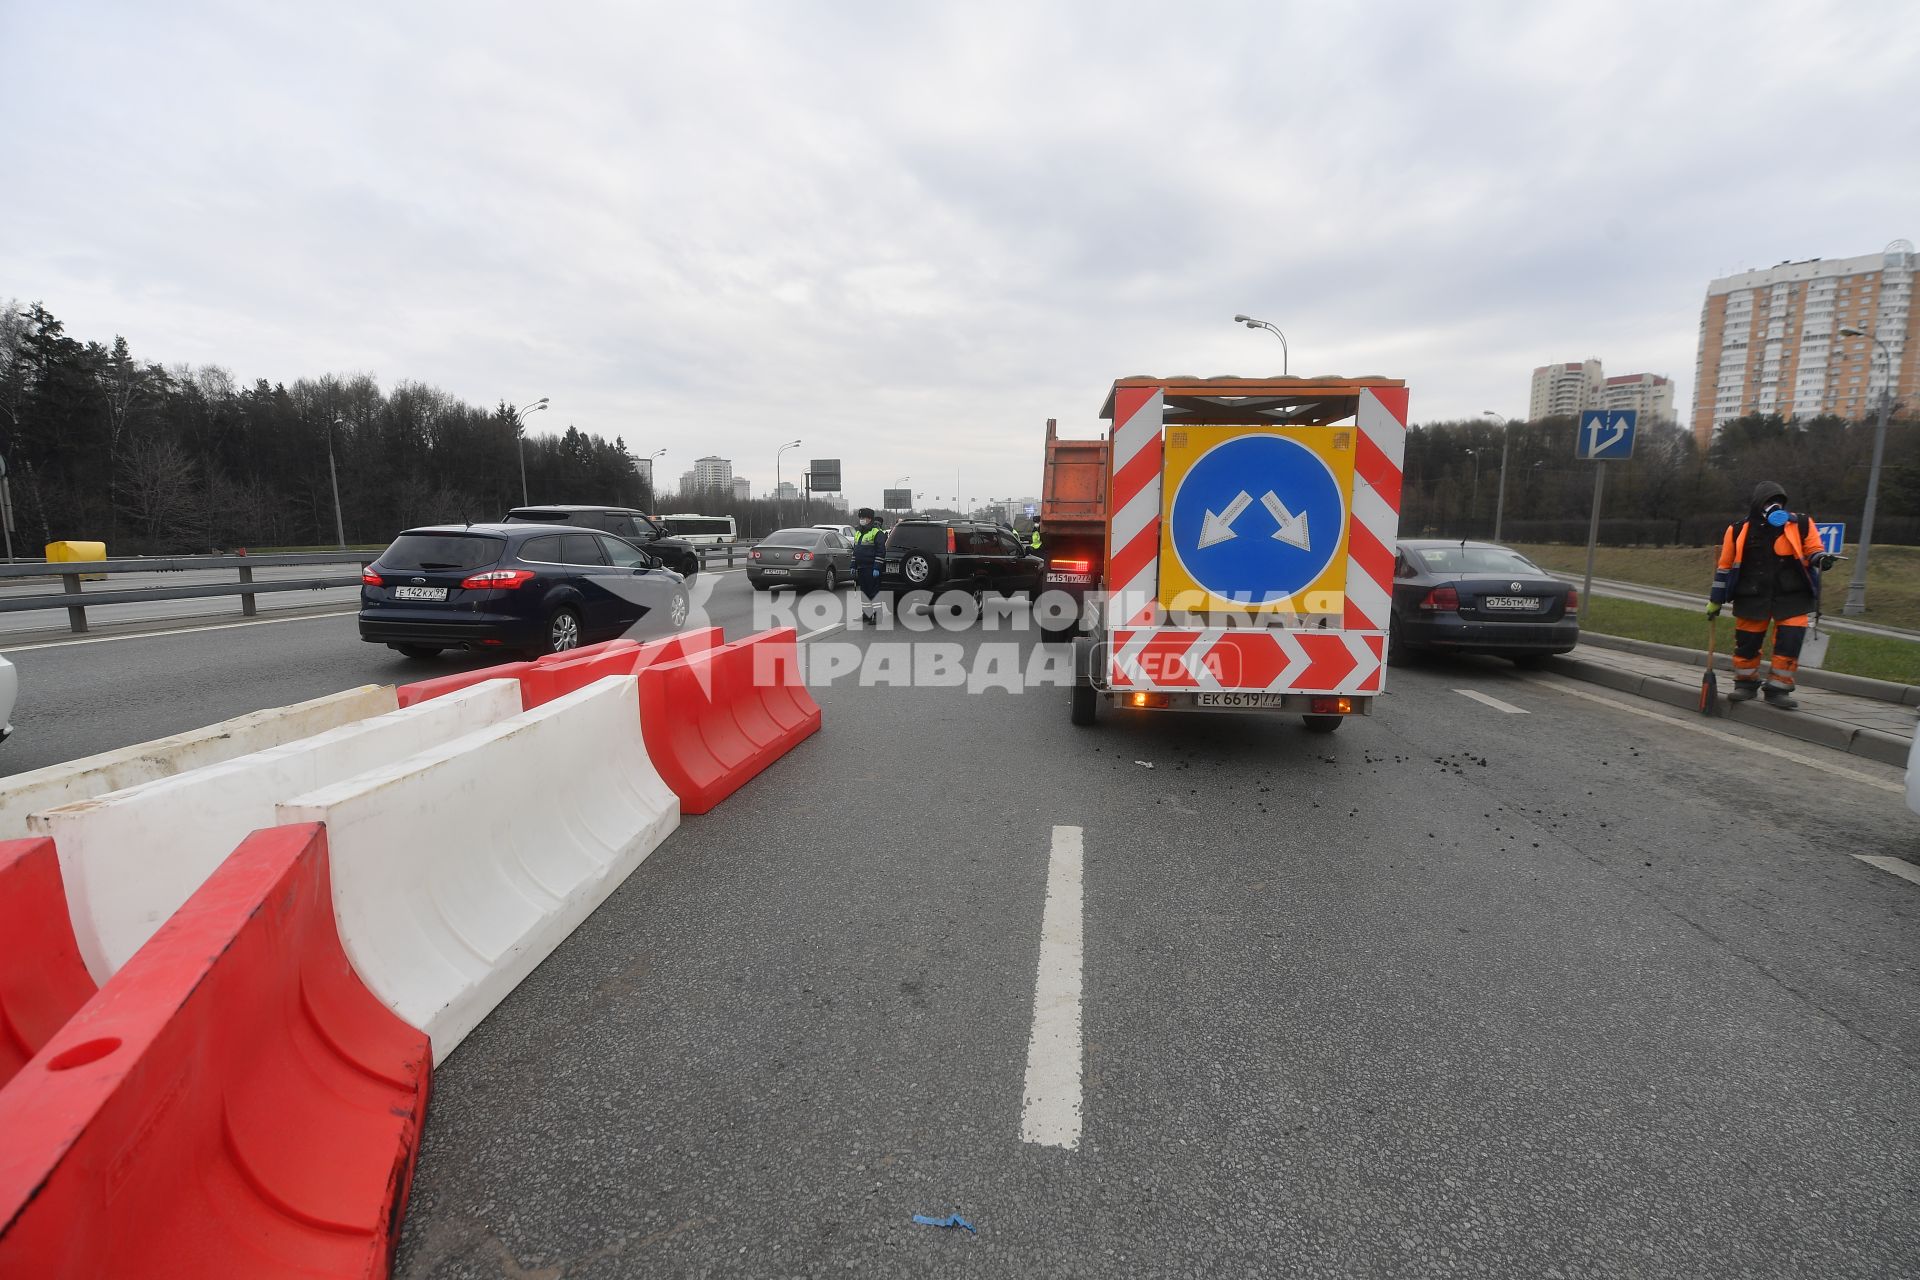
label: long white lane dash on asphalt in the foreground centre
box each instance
[1020,827,1085,1151]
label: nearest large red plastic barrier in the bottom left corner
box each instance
[0,825,432,1280]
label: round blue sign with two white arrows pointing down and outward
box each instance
[1171,434,1346,604]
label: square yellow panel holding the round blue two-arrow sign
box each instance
[1160,424,1356,622]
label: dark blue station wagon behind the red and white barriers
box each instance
[359,524,689,658]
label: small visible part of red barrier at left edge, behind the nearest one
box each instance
[0,837,94,1084]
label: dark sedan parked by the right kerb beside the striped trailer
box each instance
[1388,541,1580,666]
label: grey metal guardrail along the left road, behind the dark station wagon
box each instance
[0,543,753,633]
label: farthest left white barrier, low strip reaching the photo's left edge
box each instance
[0,685,399,841]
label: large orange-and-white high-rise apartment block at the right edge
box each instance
[1693,240,1920,445]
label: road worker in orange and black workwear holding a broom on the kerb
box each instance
[1707,480,1839,710]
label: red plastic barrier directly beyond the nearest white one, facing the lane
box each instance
[637,628,820,814]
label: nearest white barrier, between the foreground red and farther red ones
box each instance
[278,676,680,1063]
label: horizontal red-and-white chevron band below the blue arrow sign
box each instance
[1110,628,1386,693]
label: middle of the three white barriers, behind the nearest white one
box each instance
[29,679,520,983]
